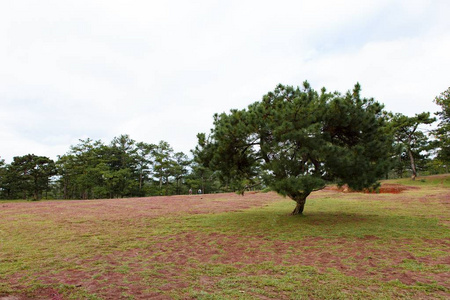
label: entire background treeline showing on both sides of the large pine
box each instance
[0,88,450,200]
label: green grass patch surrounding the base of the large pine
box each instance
[184,195,450,240]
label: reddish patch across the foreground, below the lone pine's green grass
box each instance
[24,232,450,299]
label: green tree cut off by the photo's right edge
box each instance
[434,87,450,169]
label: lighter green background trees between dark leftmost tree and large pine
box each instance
[52,135,189,199]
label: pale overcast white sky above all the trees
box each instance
[0,0,450,163]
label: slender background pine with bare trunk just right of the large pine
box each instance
[392,112,436,180]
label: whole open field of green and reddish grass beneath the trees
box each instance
[0,176,450,300]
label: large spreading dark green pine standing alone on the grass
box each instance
[202,82,392,214]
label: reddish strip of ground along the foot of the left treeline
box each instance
[0,192,281,221]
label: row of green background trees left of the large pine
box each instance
[0,135,218,200]
